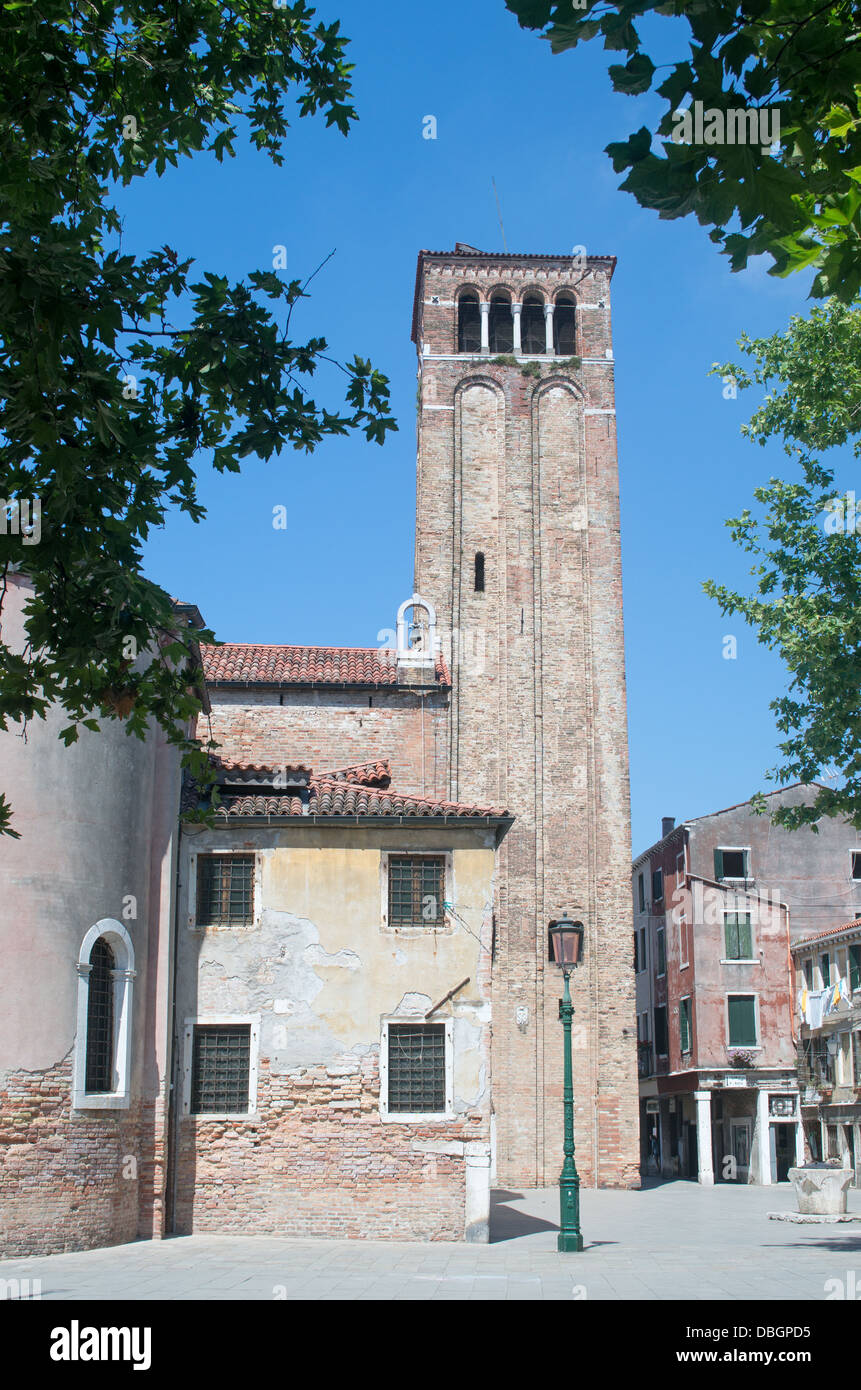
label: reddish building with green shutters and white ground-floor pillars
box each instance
[631,785,861,1184]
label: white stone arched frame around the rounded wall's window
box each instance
[72,917,135,1111]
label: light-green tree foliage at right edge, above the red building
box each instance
[704,300,861,828]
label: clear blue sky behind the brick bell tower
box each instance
[121,0,829,851]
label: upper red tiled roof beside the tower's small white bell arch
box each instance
[200,642,451,687]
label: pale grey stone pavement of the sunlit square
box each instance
[0,1180,861,1301]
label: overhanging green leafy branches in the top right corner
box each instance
[506,0,861,303]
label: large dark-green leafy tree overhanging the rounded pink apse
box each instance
[0,0,395,831]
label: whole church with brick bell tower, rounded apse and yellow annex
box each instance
[0,243,640,1254]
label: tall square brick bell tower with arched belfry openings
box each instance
[413,243,640,1187]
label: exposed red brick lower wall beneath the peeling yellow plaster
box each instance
[177,1051,488,1240]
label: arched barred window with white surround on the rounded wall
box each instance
[72,917,135,1111]
